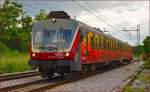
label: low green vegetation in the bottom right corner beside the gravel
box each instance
[123,58,150,92]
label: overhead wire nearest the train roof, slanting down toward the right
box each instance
[72,0,119,32]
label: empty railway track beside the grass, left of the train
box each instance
[0,71,40,82]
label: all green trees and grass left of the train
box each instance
[0,0,48,74]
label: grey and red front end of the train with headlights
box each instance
[28,18,78,77]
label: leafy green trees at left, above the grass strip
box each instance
[0,0,33,51]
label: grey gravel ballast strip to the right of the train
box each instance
[45,62,142,92]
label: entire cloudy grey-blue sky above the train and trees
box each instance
[5,0,150,45]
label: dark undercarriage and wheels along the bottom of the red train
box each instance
[29,60,130,78]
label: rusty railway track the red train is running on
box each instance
[1,65,129,92]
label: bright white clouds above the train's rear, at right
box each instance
[77,1,149,45]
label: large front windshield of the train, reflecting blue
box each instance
[33,29,75,52]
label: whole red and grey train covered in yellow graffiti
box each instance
[28,11,132,77]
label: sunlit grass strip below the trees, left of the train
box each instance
[0,51,30,73]
